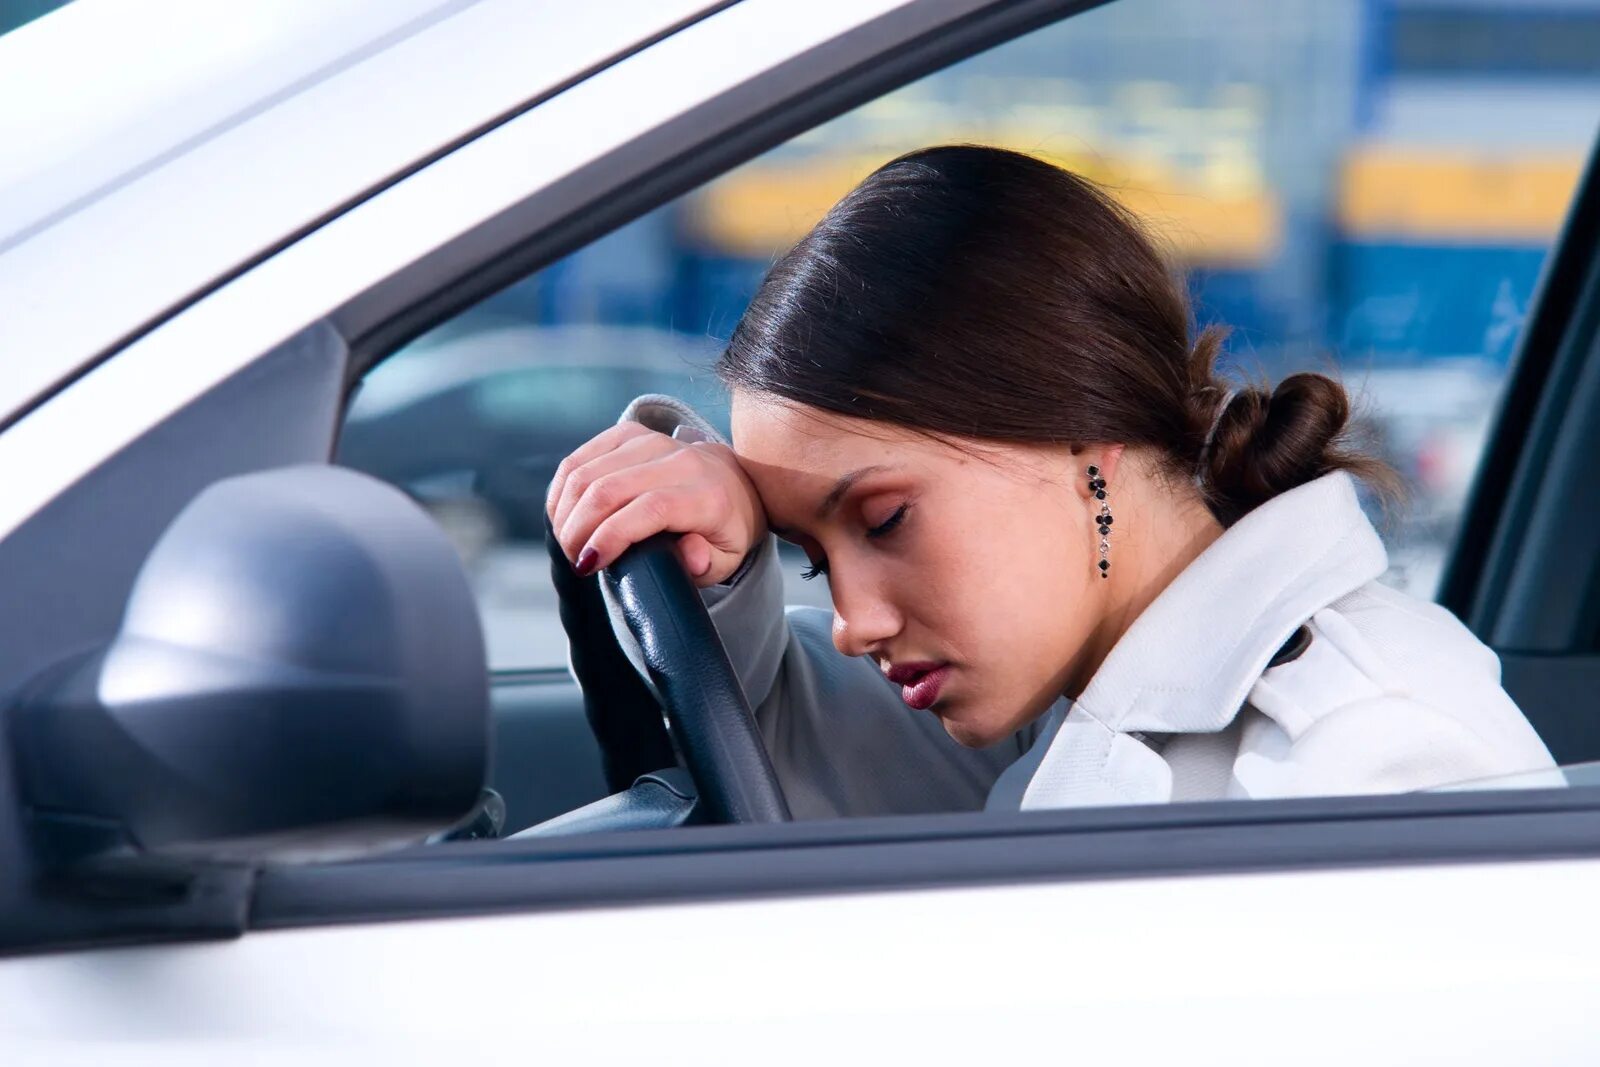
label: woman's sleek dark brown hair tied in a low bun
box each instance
[717,146,1389,523]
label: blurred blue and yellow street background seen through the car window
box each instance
[342,0,1600,667]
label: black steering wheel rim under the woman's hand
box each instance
[602,534,789,822]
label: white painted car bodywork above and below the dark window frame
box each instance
[0,0,1600,1065]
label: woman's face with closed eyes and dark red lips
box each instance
[733,392,1110,747]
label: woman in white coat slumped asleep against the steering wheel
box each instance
[549,146,1550,816]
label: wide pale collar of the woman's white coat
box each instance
[1022,470,1389,808]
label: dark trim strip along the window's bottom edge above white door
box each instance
[248,787,1600,929]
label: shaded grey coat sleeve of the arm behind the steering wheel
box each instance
[608,397,1032,819]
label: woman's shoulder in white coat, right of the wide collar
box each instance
[1240,582,1550,793]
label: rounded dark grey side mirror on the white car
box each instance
[5,466,490,861]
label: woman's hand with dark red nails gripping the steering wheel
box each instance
[546,422,766,587]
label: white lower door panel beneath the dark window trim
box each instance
[0,861,1600,1067]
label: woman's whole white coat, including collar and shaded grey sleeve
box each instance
[598,397,1554,817]
